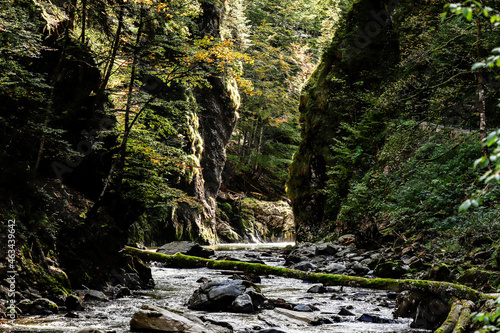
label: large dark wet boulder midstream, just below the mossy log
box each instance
[188,280,265,313]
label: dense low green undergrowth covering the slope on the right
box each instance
[328,122,488,232]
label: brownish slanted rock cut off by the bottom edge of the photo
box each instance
[130,304,209,333]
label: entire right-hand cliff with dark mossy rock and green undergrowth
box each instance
[287,0,500,241]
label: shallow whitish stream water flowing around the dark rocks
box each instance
[0,244,429,333]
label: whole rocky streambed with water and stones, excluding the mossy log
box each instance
[2,239,496,332]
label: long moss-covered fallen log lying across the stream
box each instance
[123,246,488,302]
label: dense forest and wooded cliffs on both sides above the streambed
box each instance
[0,0,500,330]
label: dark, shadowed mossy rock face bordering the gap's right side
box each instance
[287,0,399,240]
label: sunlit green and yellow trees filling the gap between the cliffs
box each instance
[226,0,332,196]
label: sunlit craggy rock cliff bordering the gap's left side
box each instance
[172,2,240,243]
